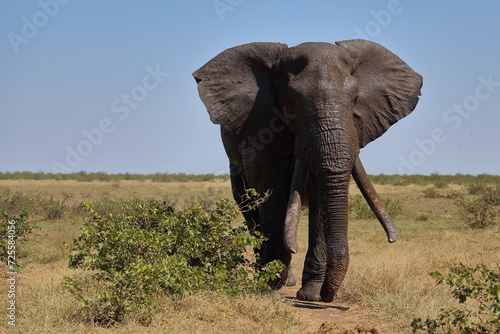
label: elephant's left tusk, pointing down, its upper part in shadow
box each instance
[283,159,308,254]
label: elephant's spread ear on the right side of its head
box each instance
[336,39,422,148]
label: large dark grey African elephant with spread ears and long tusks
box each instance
[193,40,422,302]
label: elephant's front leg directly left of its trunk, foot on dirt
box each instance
[297,182,326,301]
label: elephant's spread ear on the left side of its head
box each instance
[193,43,287,133]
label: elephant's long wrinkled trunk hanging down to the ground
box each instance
[310,112,359,302]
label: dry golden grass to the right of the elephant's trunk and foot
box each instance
[341,185,500,330]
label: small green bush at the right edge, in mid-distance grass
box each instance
[455,186,498,228]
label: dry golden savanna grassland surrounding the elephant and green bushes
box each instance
[0,173,500,333]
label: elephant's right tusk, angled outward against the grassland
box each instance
[352,157,398,242]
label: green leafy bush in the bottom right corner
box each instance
[411,264,500,334]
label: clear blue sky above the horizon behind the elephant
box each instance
[0,0,500,175]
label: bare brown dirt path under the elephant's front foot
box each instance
[280,285,396,334]
